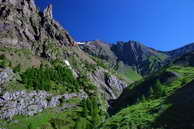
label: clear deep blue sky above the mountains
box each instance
[36,0,194,50]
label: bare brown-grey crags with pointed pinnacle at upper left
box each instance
[0,0,74,54]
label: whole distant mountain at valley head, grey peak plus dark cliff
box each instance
[81,41,168,76]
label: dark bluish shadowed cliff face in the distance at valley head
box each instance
[111,41,167,75]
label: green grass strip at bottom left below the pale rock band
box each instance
[0,108,81,129]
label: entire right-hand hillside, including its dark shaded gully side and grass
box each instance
[99,53,194,129]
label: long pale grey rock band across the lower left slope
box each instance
[0,91,87,119]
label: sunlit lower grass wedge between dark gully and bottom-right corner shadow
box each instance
[100,99,170,129]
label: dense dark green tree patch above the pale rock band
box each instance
[21,65,80,93]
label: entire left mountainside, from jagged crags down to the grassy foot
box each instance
[0,0,128,129]
